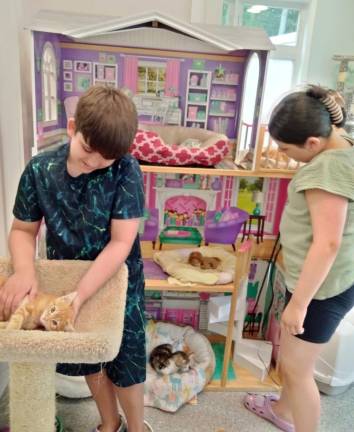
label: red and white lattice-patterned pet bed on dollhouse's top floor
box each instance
[131,125,229,166]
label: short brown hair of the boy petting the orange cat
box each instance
[75,85,138,159]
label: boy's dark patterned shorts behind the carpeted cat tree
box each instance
[57,280,146,387]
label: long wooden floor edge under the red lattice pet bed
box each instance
[140,165,296,178]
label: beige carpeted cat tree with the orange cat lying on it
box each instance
[0,259,128,432]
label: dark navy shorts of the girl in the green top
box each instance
[285,285,354,343]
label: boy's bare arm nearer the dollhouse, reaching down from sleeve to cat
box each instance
[74,218,140,312]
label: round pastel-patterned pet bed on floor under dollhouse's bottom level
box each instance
[144,321,215,412]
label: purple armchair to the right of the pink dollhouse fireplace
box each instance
[204,207,249,250]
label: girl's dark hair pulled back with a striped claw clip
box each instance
[268,86,346,145]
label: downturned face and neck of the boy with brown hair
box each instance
[67,119,115,174]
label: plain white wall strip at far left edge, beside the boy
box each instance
[0,0,24,255]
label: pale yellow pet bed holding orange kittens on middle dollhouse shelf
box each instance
[153,246,236,285]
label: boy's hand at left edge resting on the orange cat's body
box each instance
[0,273,38,321]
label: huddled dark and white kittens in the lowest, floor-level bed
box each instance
[149,344,192,375]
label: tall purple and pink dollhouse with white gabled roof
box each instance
[28,12,294,384]
